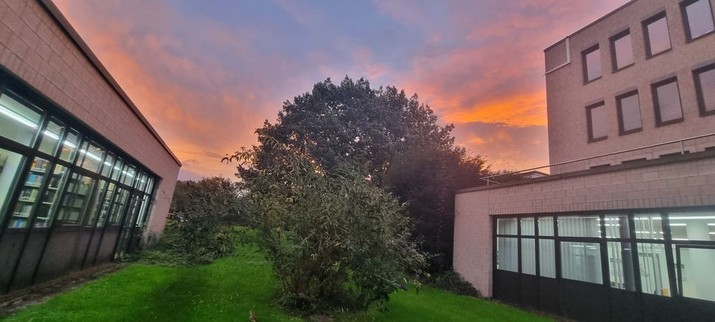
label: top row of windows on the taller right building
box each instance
[581,0,715,83]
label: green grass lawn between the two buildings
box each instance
[3,242,550,321]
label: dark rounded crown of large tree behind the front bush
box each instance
[234,77,486,271]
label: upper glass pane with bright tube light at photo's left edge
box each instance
[0,94,41,146]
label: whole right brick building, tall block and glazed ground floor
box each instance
[454,0,715,321]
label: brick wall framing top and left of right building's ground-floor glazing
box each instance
[454,152,715,296]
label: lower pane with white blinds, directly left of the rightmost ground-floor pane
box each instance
[638,243,670,296]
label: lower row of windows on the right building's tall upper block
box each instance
[586,64,715,142]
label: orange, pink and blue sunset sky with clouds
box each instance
[54,0,628,180]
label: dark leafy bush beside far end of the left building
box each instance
[164,177,242,263]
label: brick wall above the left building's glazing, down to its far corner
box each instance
[0,0,179,236]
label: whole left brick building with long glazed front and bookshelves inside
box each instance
[0,0,180,294]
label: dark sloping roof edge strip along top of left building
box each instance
[38,0,181,166]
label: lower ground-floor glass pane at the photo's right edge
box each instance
[676,248,715,301]
